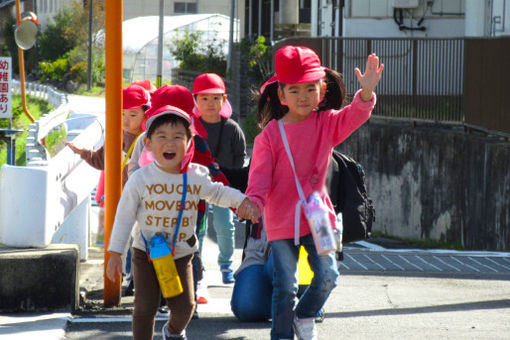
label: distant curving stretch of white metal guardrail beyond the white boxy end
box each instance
[12,80,69,165]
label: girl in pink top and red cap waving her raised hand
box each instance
[246,46,384,340]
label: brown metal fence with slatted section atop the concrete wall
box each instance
[273,37,510,134]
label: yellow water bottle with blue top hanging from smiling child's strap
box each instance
[150,234,183,298]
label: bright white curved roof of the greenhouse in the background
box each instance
[122,14,230,52]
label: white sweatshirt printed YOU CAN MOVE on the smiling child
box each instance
[108,163,246,259]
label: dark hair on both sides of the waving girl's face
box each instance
[255,69,346,128]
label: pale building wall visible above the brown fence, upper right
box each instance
[312,0,510,38]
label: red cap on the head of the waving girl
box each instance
[274,45,326,84]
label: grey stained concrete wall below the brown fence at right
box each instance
[338,117,510,250]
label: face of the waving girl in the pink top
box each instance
[278,81,323,121]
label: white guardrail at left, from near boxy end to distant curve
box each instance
[0,83,104,260]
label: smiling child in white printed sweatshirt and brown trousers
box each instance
[106,105,260,340]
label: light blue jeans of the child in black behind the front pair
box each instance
[211,204,235,266]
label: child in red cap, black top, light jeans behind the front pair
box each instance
[193,73,246,284]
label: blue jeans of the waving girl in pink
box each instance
[271,234,338,340]
